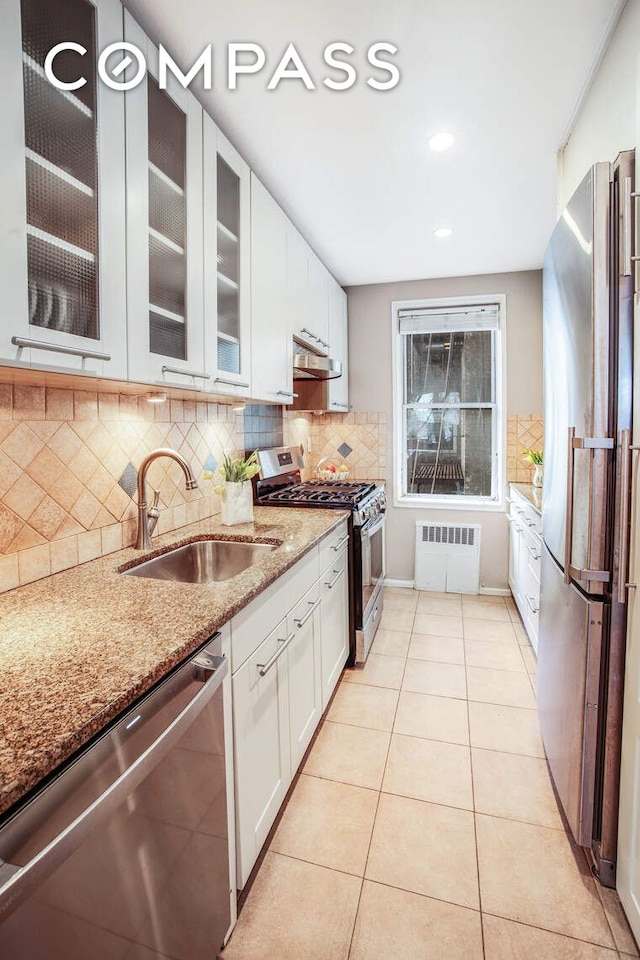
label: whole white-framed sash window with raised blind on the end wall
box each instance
[393,297,504,507]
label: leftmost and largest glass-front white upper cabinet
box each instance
[0,0,126,377]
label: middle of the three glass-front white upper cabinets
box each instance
[125,13,206,389]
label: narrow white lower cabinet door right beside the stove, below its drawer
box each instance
[320,546,349,710]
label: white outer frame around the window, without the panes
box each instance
[391,294,507,511]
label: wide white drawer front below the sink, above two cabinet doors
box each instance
[231,547,318,673]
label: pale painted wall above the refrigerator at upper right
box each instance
[558,0,640,210]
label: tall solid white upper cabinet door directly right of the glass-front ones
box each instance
[251,175,294,403]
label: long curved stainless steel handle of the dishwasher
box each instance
[0,650,229,921]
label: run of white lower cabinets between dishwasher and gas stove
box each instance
[231,522,349,889]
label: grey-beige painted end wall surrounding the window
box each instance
[347,270,542,588]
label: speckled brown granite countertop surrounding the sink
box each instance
[0,507,347,814]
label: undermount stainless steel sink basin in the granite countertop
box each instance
[123,540,277,583]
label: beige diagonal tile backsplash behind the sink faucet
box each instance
[0,384,244,590]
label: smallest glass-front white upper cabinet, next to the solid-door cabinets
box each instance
[203,121,251,396]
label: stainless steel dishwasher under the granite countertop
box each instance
[0,634,230,960]
